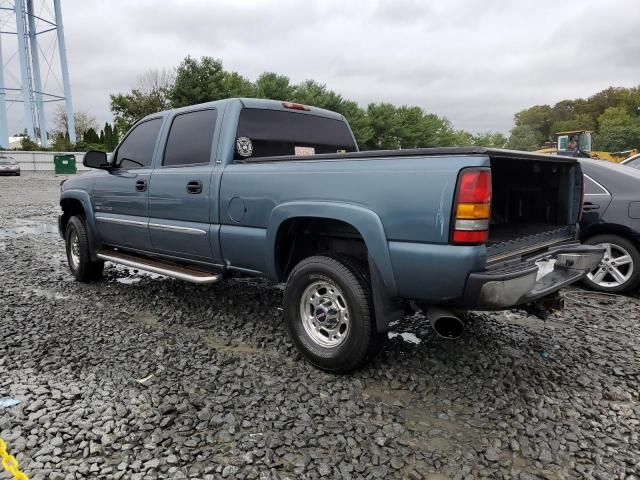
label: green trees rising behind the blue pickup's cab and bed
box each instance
[110,56,507,150]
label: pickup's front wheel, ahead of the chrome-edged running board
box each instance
[64,216,104,282]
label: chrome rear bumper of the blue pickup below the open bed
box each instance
[463,243,604,310]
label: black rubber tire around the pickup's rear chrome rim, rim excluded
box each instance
[284,255,381,373]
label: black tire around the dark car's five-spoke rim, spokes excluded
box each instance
[582,233,640,293]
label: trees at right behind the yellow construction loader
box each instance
[508,86,640,151]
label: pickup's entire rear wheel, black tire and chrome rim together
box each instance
[284,255,377,373]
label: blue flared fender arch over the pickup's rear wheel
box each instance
[265,201,397,297]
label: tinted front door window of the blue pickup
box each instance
[114,118,162,169]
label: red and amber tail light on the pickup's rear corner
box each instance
[451,168,491,245]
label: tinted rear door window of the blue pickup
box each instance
[162,110,217,166]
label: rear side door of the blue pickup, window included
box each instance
[149,108,219,263]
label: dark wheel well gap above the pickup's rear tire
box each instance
[275,217,367,281]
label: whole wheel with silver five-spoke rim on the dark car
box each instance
[583,234,640,293]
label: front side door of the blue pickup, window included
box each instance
[92,117,163,251]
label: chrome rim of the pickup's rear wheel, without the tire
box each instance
[300,281,350,348]
